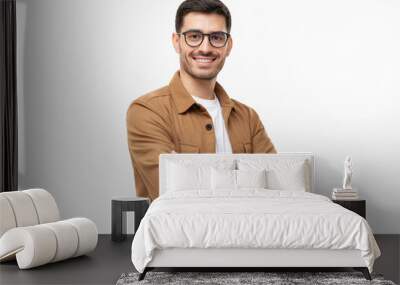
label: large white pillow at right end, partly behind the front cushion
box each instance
[238,158,311,191]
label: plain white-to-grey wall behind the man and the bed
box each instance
[17,0,400,234]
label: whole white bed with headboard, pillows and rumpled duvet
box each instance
[131,153,380,280]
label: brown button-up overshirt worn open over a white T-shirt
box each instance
[126,71,276,200]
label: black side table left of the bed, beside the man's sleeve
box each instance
[111,197,149,241]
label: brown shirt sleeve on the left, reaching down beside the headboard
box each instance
[126,101,174,201]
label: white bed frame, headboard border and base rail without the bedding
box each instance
[139,153,371,280]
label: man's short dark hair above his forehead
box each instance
[175,0,232,33]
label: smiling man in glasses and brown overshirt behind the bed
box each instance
[126,0,276,201]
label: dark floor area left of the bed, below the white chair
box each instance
[0,235,135,285]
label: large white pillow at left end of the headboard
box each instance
[166,162,211,192]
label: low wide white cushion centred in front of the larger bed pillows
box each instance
[211,168,267,190]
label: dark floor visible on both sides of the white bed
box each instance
[0,235,400,285]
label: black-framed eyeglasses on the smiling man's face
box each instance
[178,30,230,48]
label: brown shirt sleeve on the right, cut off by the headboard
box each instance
[250,108,277,153]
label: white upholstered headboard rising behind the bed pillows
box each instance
[159,152,315,195]
